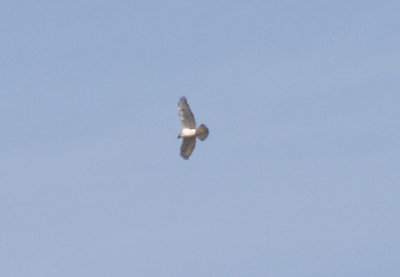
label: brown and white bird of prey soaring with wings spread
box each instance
[178,96,208,160]
